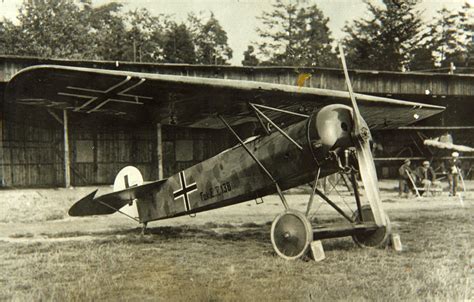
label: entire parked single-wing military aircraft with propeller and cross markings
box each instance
[6,49,444,259]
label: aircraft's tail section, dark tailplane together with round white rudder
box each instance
[69,167,166,217]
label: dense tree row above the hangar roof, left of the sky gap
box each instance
[0,0,232,64]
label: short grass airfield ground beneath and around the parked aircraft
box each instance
[0,180,474,301]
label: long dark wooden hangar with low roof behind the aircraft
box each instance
[0,56,474,187]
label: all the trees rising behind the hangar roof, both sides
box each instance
[0,0,474,72]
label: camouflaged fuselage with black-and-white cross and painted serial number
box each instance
[137,120,335,222]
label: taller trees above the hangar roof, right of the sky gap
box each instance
[246,0,474,72]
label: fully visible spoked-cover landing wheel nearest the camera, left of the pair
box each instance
[270,210,313,260]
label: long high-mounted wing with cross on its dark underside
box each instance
[5,65,444,129]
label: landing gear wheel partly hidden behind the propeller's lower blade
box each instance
[352,205,392,247]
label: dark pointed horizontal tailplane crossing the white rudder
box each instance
[68,179,166,216]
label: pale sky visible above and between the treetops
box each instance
[0,0,468,65]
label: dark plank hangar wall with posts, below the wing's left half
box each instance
[0,96,229,187]
